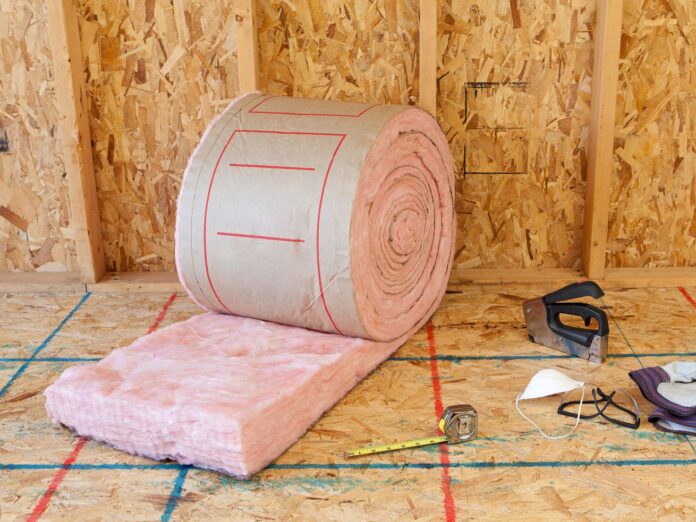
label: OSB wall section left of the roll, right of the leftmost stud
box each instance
[78,0,238,271]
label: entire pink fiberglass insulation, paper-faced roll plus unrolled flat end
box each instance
[45,93,455,477]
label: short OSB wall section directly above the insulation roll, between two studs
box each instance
[257,0,418,104]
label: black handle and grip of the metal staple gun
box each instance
[543,281,609,348]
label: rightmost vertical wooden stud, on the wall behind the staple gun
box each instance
[582,0,623,279]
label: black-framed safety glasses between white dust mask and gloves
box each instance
[558,384,640,430]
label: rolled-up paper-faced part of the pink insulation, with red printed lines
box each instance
[176,94,454,341]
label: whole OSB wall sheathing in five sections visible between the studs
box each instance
[6,0,696,271]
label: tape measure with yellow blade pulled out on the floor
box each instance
[345,404,478,458]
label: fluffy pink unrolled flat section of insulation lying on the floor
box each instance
[45,313,398,477]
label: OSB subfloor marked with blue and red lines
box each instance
[0,286,696,520]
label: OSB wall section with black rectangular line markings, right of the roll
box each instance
[438,0,595,268]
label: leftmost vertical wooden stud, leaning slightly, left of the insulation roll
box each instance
[48,0,105,283]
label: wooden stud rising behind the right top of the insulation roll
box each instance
[418,0,437,116]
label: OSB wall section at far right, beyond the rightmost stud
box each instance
[608,0,696,267]
